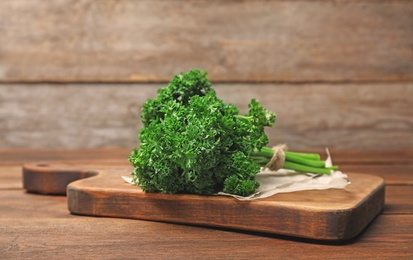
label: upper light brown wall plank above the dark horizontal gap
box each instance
[0,0,413,82]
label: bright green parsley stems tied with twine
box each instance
[251,147,338,174]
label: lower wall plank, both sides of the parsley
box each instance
[0,83,413,150]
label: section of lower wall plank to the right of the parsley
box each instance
[217,83,413,150]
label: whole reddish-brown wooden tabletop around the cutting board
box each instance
[0,149,413,259]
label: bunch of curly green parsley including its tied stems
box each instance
[129,70,338,196]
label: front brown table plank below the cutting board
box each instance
[0,190,413,259]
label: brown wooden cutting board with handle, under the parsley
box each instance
[23,164,385,241]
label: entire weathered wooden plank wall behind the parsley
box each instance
[0,0,413,150]
